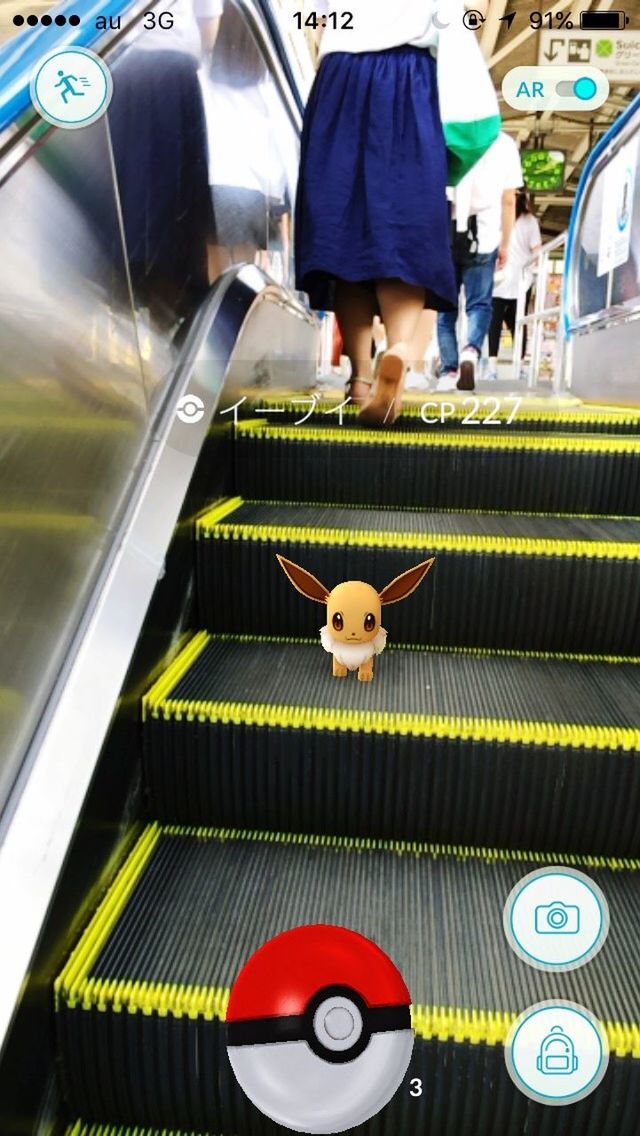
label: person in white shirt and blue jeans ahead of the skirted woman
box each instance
[438,132,524,391]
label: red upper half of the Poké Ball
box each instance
[226,924,412,1021]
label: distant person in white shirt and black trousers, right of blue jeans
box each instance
[487,190,542,379]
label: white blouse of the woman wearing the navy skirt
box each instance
[305,0,441,56]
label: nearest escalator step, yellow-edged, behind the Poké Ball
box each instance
[56,825,640,1136]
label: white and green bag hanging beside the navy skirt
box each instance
[434,0,501,185]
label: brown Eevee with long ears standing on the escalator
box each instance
[277,556,433,683]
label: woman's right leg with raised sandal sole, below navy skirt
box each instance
[360,279,424,426]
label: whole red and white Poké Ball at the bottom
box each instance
[226,925,414,1133]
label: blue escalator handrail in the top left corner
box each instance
[0,0,138,133]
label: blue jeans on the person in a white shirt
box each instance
[438,249,498,375]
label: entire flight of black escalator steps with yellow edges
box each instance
[55,394,640,1136]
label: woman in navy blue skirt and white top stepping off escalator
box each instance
[296,0,487,426]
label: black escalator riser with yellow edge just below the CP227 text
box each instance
[234,419,640,516]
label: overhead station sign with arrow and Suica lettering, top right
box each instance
[538,28,640,86]
